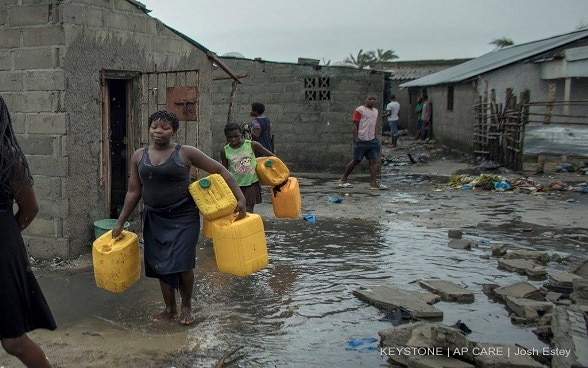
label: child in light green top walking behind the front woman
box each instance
[220,123,274,212]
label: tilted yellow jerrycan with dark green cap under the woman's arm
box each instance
[188,174,237,221]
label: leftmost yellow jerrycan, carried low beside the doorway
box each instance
[92,230,141,293]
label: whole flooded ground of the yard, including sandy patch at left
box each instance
[0,137,588,368]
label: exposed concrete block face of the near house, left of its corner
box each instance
[0,1,69,258]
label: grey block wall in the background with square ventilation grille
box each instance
[213,58,386,174]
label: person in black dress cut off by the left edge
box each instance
[0,96,57,368]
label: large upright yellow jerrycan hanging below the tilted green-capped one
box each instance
[212,213,269,277]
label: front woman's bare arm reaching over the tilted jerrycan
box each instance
[181,146,246,220]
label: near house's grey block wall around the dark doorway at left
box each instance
[0,0,212,258]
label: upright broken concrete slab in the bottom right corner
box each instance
[551,306,588,368]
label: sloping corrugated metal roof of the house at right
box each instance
[400,29,588,88]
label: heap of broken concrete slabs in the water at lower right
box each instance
[354,249,588,368]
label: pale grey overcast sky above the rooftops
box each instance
[140,0,588,63]
